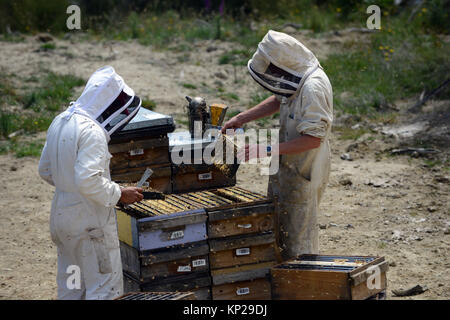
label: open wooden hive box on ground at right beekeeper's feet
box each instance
[271,255,388,300]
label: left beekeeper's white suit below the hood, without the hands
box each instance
[39,114,123,300]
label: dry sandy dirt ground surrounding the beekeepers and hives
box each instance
[0,33,450,299]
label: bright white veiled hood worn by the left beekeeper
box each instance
[64,66,141,139]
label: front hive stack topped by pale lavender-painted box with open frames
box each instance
[117,195,211,299]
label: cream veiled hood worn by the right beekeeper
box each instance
[247,30,319,97]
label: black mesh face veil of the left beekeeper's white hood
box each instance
[97,91,141,135]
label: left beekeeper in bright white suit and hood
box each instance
[39,66,143,299]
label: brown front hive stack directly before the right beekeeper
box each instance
[206,187,276,300]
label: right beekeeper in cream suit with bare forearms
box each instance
[223,30,333,259]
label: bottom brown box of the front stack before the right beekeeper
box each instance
[211,262,275,300]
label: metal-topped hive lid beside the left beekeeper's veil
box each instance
[111,108,175,143]
